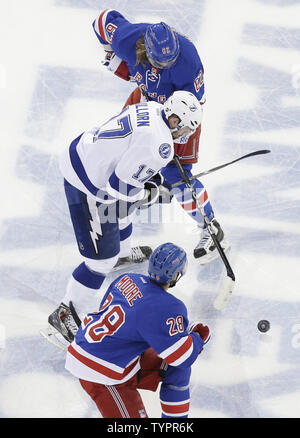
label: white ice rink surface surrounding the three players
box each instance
[0,0,300,418]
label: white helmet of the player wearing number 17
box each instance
[163,91,203,133]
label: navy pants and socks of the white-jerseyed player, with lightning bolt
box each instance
[62,176,132,316]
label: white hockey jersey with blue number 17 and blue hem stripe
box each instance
[60,102,174,203]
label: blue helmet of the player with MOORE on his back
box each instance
[148,242,187,287]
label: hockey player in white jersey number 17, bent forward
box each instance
[44,92,202,342]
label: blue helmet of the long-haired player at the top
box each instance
[144,22,180,68]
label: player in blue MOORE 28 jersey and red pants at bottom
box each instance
[65,243,209,418]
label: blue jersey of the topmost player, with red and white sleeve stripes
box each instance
[93,9,205,103]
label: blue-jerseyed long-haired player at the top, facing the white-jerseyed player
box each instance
[93,9,229,264]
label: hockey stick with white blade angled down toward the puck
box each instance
[174,154,235,310]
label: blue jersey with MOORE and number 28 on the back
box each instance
[65,274,204,385]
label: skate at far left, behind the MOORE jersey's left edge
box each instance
[40,301,81,351]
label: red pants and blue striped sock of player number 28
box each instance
[80,348,191,418]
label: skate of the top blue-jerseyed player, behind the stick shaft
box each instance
[194,219,230,265]
